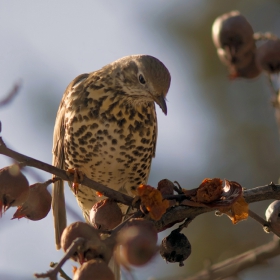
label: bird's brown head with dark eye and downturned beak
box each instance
[111,55,171,114]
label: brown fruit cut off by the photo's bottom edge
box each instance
[73,259,115,280]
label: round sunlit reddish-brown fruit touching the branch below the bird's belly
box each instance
[90,199,122,230]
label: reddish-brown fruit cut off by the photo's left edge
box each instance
[0,164,29,216]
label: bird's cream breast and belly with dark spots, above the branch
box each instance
[64,98,156,197]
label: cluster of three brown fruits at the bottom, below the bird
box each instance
[61,219,158,280]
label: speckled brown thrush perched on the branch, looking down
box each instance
[52,54,171,252]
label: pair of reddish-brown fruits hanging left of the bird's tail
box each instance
[0,164,52,221]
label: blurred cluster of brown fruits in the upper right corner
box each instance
[212,11,280,79]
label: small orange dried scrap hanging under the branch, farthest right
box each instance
[218,196,249,224]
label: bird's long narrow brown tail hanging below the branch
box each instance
[52,177,66,250]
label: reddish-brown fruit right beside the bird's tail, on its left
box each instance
[13,180,52,221]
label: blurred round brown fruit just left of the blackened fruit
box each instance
[118,226,158,266]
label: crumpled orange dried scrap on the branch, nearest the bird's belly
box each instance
[137,185,170,221]
